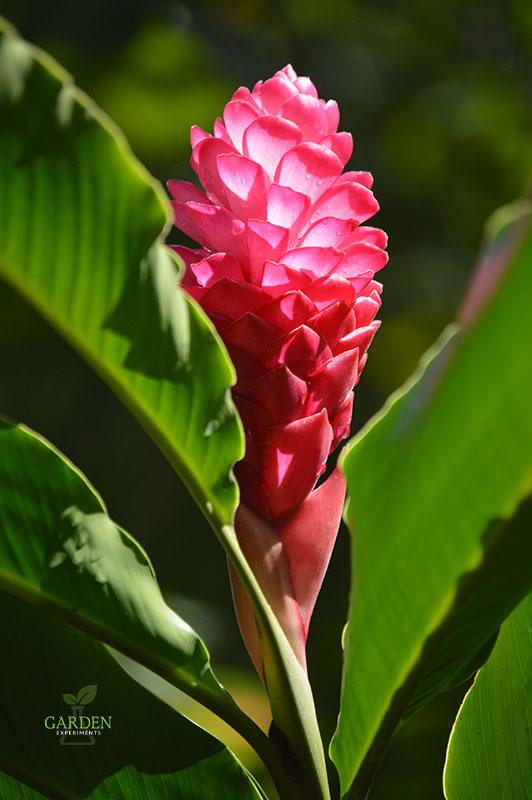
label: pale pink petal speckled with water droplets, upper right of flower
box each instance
[275,142,342,202]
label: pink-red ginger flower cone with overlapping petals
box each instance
[169,66,387,679]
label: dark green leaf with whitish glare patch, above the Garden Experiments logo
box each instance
[0,421,267,758]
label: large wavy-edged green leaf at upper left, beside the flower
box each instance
[0,18,243,530]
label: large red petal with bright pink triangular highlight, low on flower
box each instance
[262,410,332,517]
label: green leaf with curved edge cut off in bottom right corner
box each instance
[444,588,532,800]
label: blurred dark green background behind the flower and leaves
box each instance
[0,0,532,800]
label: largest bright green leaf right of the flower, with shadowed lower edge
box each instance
[331,202,532,798]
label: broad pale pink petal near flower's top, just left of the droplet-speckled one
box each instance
[242,115,302,177]
